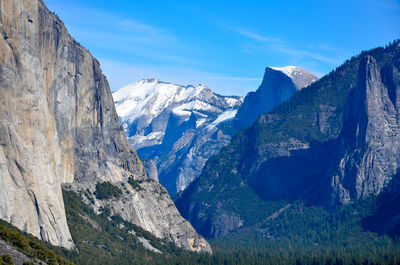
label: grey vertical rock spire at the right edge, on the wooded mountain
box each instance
[332,55,400,203]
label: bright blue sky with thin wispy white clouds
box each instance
[44,0,400,95]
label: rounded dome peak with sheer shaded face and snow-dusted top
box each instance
[233,66,318,130]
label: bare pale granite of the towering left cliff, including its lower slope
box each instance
[0,0,211,252]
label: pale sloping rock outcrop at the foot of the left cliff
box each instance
[64,178,211,253]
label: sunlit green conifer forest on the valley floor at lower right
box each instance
[208,198,400,264]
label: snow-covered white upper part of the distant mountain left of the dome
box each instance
[113,78,242,137]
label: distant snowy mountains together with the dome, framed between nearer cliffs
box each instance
[113,66,318,196]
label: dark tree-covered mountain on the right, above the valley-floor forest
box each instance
[176,42,400,237]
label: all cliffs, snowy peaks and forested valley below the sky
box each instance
[0,0,400,265]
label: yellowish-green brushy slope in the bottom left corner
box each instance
[0,220,74,265]
